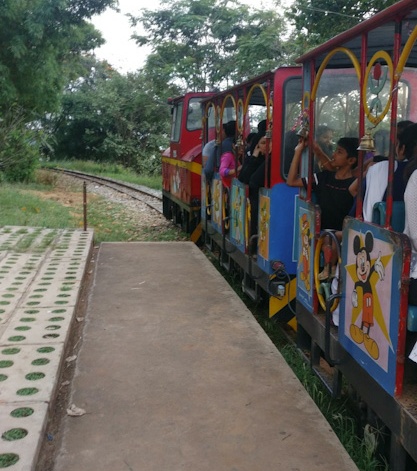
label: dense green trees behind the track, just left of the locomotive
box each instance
[45,62,174,173]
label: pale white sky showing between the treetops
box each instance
[93,0,291,74]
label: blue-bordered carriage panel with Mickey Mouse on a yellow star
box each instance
[339,218,409,395]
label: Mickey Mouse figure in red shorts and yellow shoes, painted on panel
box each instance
[350,232,385,360]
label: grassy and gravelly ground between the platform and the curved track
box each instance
[0,170,187,243]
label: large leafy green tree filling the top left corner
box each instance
[0,0,115,112]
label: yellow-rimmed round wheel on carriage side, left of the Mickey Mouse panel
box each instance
[314,231,340,312]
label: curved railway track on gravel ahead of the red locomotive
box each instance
[52,168,162,214]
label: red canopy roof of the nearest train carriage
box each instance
[296,0,417,69]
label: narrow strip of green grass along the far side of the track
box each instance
[44,160,162,190]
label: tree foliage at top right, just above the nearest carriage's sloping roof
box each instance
[286,0,397,57]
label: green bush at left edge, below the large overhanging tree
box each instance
[0,107,41,182]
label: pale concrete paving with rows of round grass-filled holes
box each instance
[0,226,93,471]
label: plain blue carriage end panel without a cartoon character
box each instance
[258,183,298,275]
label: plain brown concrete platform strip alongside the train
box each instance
[52,242,357,471]
